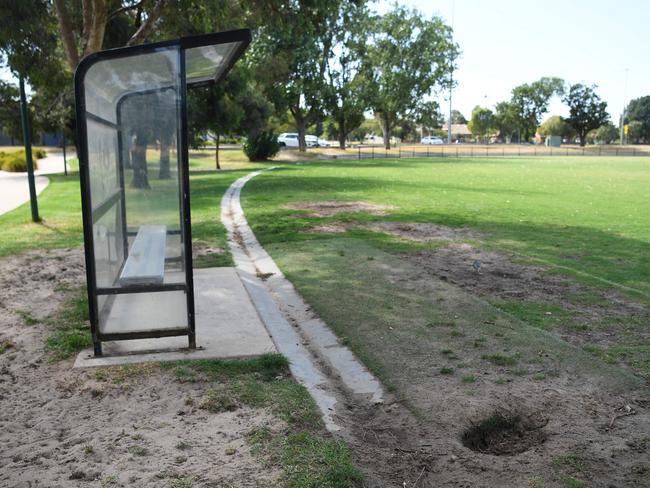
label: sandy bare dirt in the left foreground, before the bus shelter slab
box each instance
[0,249,282,488]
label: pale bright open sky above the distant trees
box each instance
[376,0,650,124]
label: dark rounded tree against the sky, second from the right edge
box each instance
[563,83,609,146]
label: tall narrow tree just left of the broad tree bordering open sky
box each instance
[327,2,368,149]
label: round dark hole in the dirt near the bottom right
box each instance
[462,411,548,456]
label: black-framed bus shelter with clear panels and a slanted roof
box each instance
[75,29,251,356]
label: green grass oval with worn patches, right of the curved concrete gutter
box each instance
[238,157,650,385]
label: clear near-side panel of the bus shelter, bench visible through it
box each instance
[84,47,189,337]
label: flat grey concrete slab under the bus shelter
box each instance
[74,268,276,368]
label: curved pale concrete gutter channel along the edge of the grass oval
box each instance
[221,168,384,431]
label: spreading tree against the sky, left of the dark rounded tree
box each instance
[510,77,564,140]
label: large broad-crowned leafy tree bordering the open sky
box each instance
[366,6,458,149]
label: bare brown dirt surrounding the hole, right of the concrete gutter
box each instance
[332,241,650,487]
